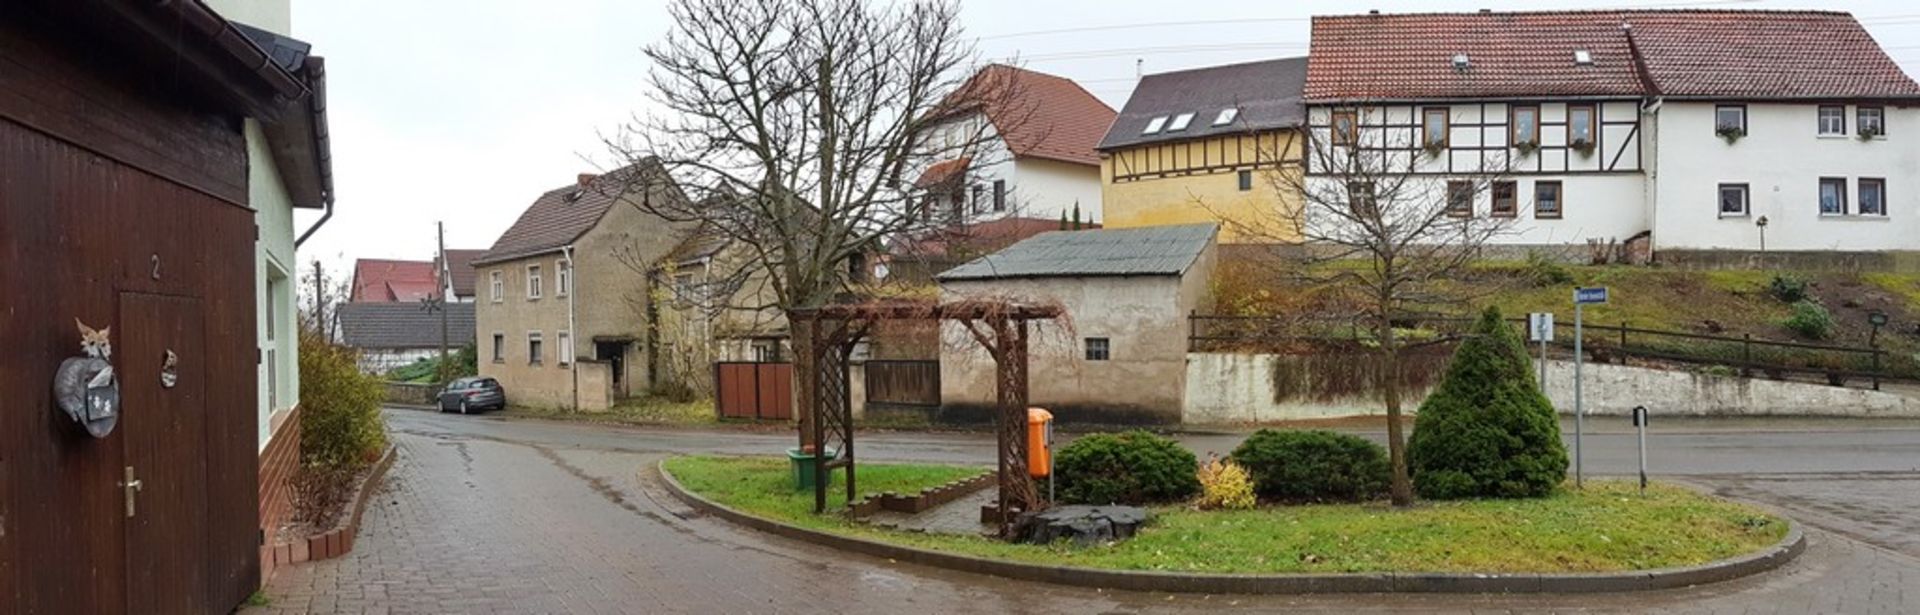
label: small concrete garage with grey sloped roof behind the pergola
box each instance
[935,223,1219,425]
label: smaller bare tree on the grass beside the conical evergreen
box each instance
[1236,106,1517,505]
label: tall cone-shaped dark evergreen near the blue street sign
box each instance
[1407,308,1567,500]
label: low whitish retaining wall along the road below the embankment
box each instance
[1181,352,1920,425]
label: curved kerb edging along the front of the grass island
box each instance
[655,459,1807,594]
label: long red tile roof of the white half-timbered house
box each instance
[1306,10,1920,102]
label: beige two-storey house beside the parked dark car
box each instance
[474,160,685,409]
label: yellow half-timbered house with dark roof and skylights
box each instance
[1100,58,1308,244]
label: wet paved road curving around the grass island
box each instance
[257,411,1920,613]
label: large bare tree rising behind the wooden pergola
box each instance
[609,0,1012,446]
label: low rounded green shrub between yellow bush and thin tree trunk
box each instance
[1231,429,1392,502]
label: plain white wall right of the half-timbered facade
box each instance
[1653,102,1920,250]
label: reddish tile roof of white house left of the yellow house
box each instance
[941,63,1117,167]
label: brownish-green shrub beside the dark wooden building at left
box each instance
[300,332,386,467]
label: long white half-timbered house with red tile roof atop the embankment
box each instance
[1306,10,1920,258]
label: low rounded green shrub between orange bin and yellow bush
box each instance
[1054,431,1200,504]
